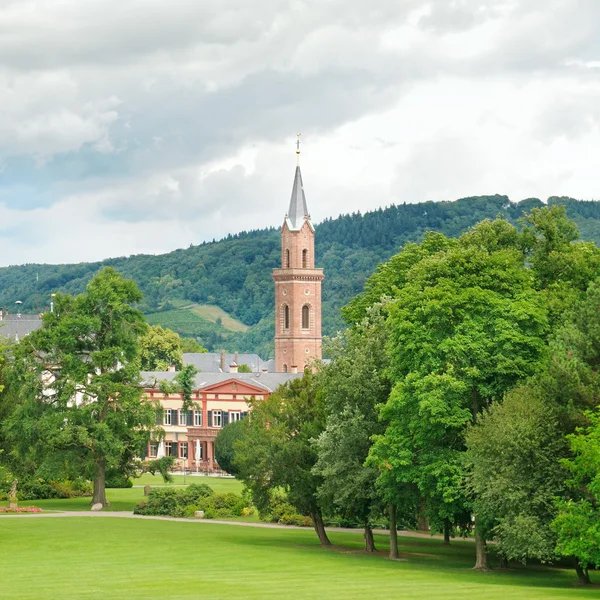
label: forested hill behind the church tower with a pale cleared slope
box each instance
[0,195,600,357]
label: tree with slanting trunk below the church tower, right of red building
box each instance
[234,371,330,545]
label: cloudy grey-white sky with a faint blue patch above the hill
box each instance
[0,0,600,265]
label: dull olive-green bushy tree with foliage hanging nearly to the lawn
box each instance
[466,381,568,562]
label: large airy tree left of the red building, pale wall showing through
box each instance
[6,268,155,506]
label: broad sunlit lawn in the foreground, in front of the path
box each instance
[0,516,600,600]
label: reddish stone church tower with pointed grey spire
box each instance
[273,142,324,373]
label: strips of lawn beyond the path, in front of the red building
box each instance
[0,474,242,512]
